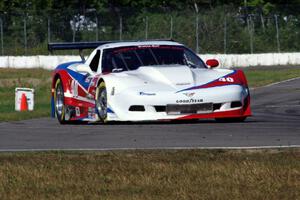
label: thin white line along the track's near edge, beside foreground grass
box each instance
[0,145,300,152]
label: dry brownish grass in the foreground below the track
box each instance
[0,149,300,200]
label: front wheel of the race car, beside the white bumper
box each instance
[96,82,107,122]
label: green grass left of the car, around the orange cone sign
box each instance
[0,68,51,121]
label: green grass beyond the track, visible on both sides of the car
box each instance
[0,67,300,121]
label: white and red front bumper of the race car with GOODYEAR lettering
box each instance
[107,85,251,121]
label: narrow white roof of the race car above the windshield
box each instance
[97,40,183,50]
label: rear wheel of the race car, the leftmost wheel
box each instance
[54,78,66,124]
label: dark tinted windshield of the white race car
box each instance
[102,45,206,72]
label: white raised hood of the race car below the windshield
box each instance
[110,65,232,91]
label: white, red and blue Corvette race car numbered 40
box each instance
[48,40,251,124]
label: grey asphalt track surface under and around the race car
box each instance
[0,78,300,151]
